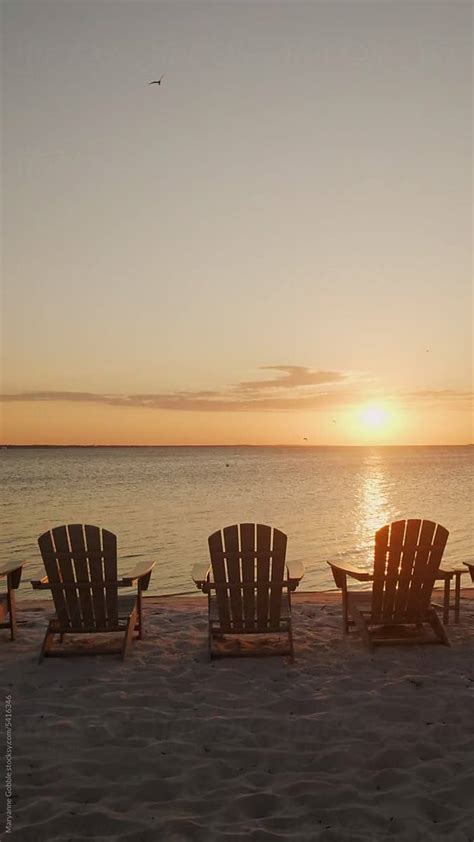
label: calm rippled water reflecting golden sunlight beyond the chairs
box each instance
[0,446,474,597]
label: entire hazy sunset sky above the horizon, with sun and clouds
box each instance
[1,0,472,445]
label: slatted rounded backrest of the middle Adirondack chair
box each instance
[209,523,287,633]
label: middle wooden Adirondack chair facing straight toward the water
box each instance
[192,523,304,658]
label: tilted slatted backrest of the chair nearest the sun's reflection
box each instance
[372,518,449,624]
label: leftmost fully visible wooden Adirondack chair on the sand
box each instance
[31,524,154,661]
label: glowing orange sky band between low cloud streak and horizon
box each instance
[3,372,472,445]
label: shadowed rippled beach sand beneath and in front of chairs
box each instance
[0,589,474,842]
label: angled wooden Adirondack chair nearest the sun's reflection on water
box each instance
[328,519,449,648]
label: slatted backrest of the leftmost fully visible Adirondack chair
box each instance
[38,524,118,631]
